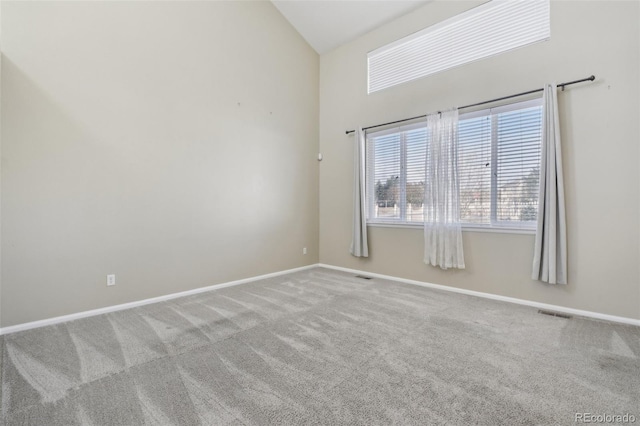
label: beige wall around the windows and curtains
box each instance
[320,1,640,319]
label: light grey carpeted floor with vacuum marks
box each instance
[2,268,640,426]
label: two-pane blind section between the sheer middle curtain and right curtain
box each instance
[458,99,542,228]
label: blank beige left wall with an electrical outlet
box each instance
[1,1,319,327]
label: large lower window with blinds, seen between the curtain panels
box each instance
[366,99,542,229]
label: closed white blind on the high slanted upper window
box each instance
[368,0,551,93]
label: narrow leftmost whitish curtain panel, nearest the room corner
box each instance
[349,128,369,257]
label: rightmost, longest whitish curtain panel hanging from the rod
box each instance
[531,84,567,284]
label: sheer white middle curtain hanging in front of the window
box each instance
[424,109,464,269]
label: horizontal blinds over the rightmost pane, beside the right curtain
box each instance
[496,106,542,225]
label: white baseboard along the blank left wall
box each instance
[0,263,318,335]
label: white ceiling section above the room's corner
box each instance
[271,0,430,54]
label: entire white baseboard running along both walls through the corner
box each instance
[0,263,640,335]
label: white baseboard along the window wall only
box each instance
[318,263,640,327]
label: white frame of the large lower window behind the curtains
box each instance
[365,96,543,234]
